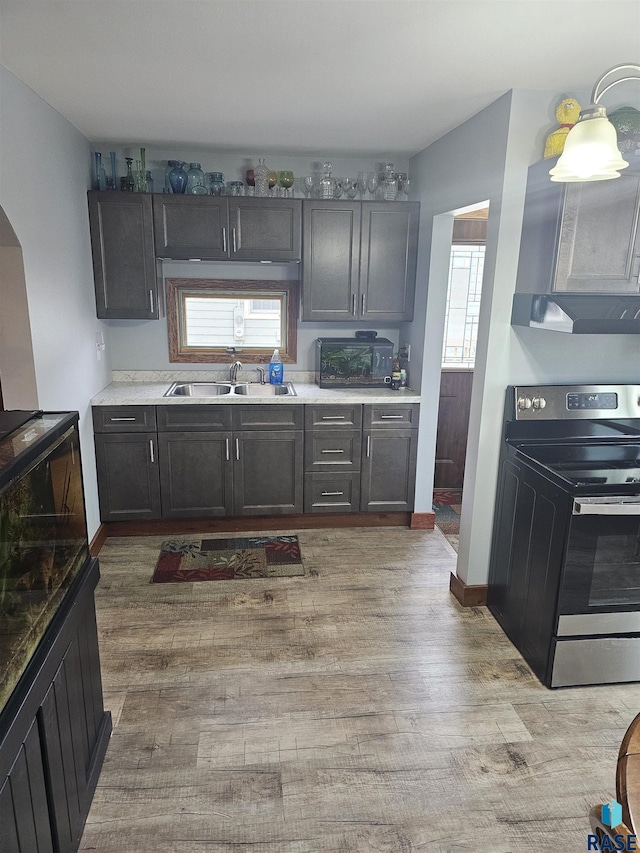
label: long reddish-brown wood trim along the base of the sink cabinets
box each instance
[102,512,411,538]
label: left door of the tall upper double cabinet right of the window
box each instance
[302,201,362,321]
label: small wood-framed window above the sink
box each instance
[166,278,298,364]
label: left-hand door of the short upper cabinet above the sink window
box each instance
[153,193,229,260]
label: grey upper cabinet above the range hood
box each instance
[516,159,640,293]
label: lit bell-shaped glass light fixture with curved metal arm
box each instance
[549,64,640,183]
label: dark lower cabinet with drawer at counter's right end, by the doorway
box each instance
[360,404,419,512]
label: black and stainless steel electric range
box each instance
[487,385,640,687]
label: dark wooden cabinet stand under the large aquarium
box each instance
[0,560,111,853]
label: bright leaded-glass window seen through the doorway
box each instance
[442,244,485,368]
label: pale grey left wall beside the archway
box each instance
[0,66,111,537]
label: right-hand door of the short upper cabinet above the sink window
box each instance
[228,198,302,261]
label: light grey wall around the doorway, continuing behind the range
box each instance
[408,90,640,584]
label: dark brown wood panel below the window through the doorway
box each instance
[433,370,473,489]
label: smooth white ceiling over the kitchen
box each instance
[0,0,640,156]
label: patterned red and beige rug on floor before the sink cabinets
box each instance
[151,536,304,583]
